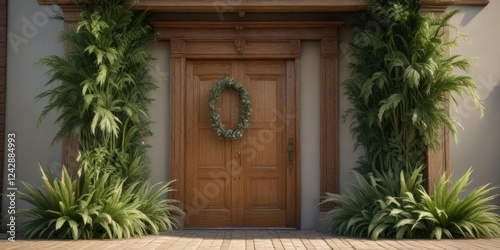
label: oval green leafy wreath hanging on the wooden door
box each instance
[208,77,252,140]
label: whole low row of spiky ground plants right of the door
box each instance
[323,168,500,240]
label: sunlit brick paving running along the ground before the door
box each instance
[0,230,500,250]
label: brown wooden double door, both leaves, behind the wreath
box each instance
[184,60,298,227]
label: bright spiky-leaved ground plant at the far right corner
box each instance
[413,169,500,239]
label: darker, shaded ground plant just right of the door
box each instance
[323,167,423,239]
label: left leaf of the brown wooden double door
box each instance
[185,62,233,227]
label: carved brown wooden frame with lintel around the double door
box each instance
[153,22,343,229]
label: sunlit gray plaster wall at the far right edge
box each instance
[450,1,500,205]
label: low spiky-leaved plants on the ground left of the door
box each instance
[19,167,182,240]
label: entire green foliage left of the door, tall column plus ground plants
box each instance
[16,0,182,239]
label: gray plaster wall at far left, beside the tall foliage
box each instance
[2,0,64,215]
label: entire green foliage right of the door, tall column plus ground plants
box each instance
[324,0,500,239]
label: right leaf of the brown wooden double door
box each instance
[241,61,287,227]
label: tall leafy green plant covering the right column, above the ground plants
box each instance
[344,0,483,172]
